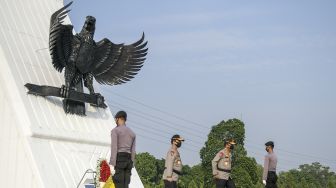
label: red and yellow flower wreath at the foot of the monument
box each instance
[95,159,115,188]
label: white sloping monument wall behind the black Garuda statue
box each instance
[0,0,143,188]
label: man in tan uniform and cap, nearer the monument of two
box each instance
[163,134,184,188]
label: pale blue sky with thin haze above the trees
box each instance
[65,0,336,171]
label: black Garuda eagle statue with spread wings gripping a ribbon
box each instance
[25,2,148,115]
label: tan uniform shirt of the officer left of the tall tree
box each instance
[163,149,182,181]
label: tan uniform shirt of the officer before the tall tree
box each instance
[211,149,232,180]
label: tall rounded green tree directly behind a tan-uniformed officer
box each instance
[200,119,259,188]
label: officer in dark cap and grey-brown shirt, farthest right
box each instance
[263,141,278,188]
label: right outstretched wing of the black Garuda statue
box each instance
[91,34,148,85]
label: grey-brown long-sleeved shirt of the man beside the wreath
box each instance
[110,125,135,166]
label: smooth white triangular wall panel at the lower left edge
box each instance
[0,71,42,188]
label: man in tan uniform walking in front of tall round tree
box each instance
[212,139,236,188]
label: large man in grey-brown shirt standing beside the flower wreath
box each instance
[110,111,135,188]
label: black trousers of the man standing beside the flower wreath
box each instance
[112,152,133,188]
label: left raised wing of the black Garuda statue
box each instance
[49,2,73,72]
